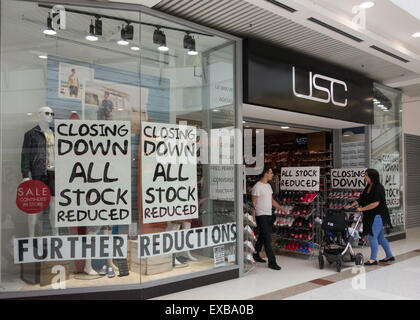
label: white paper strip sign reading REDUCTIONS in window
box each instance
[138,223,236,258]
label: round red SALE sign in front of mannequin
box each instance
[16,180,51,214]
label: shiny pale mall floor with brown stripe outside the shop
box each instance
[155,228,420,300]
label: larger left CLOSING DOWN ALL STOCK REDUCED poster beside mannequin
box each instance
[55,120,131,227]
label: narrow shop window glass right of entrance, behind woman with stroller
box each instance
[371,84,405,233]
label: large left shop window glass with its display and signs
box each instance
[0,0,237,294]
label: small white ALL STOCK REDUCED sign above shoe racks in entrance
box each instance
[280,167,319,191]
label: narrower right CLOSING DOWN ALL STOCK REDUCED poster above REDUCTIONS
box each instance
[141,122,198,223]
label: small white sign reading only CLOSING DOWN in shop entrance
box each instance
[331,168,366,190]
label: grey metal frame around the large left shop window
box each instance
[0,0,244,300]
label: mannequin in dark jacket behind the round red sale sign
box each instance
[21,106,58,237]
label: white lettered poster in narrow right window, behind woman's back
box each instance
[382,153,400,208]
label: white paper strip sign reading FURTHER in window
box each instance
[13,234,127,264]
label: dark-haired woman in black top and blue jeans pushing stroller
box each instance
[344,169,395,266]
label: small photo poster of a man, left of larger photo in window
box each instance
[58,62,95,100]
